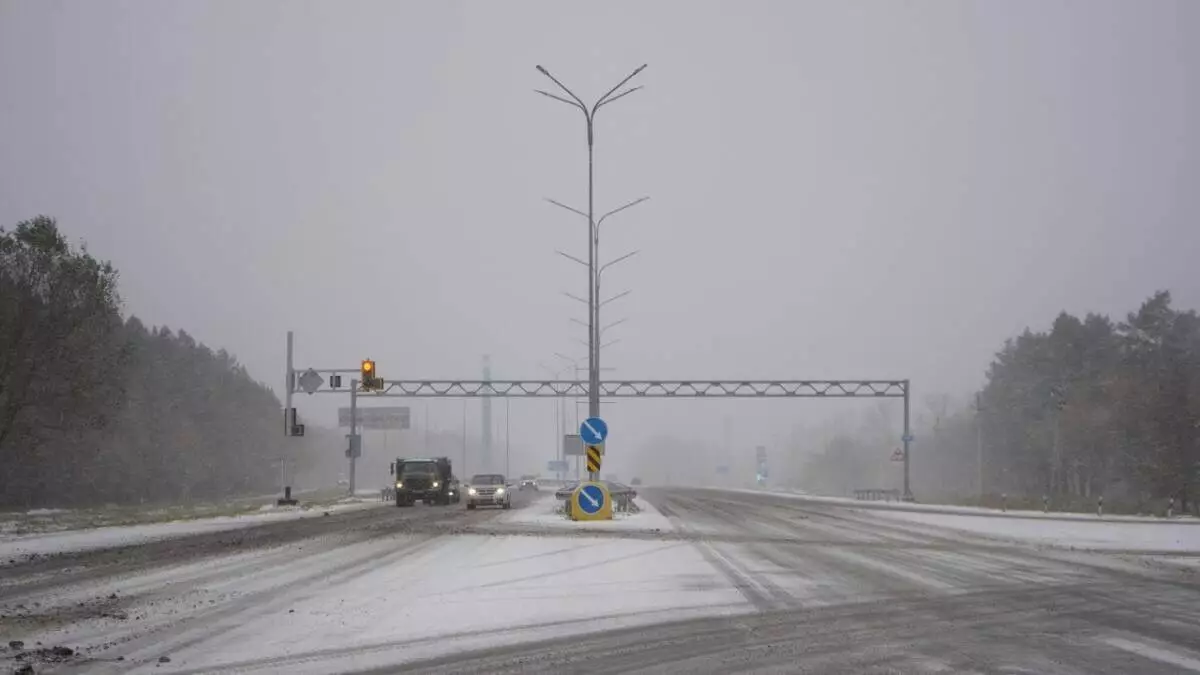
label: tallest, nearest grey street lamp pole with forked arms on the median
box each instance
[536,65,646,480]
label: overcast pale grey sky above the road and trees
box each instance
[0,0,1200,473]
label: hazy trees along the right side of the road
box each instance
[793,291,1200,513]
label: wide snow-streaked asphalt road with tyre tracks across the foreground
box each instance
[0,489,1200,673]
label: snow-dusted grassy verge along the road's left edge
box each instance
[0,496,383,563]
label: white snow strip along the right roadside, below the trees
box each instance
[863,510,1200,554]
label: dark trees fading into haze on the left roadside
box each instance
[0,216,309,508]
